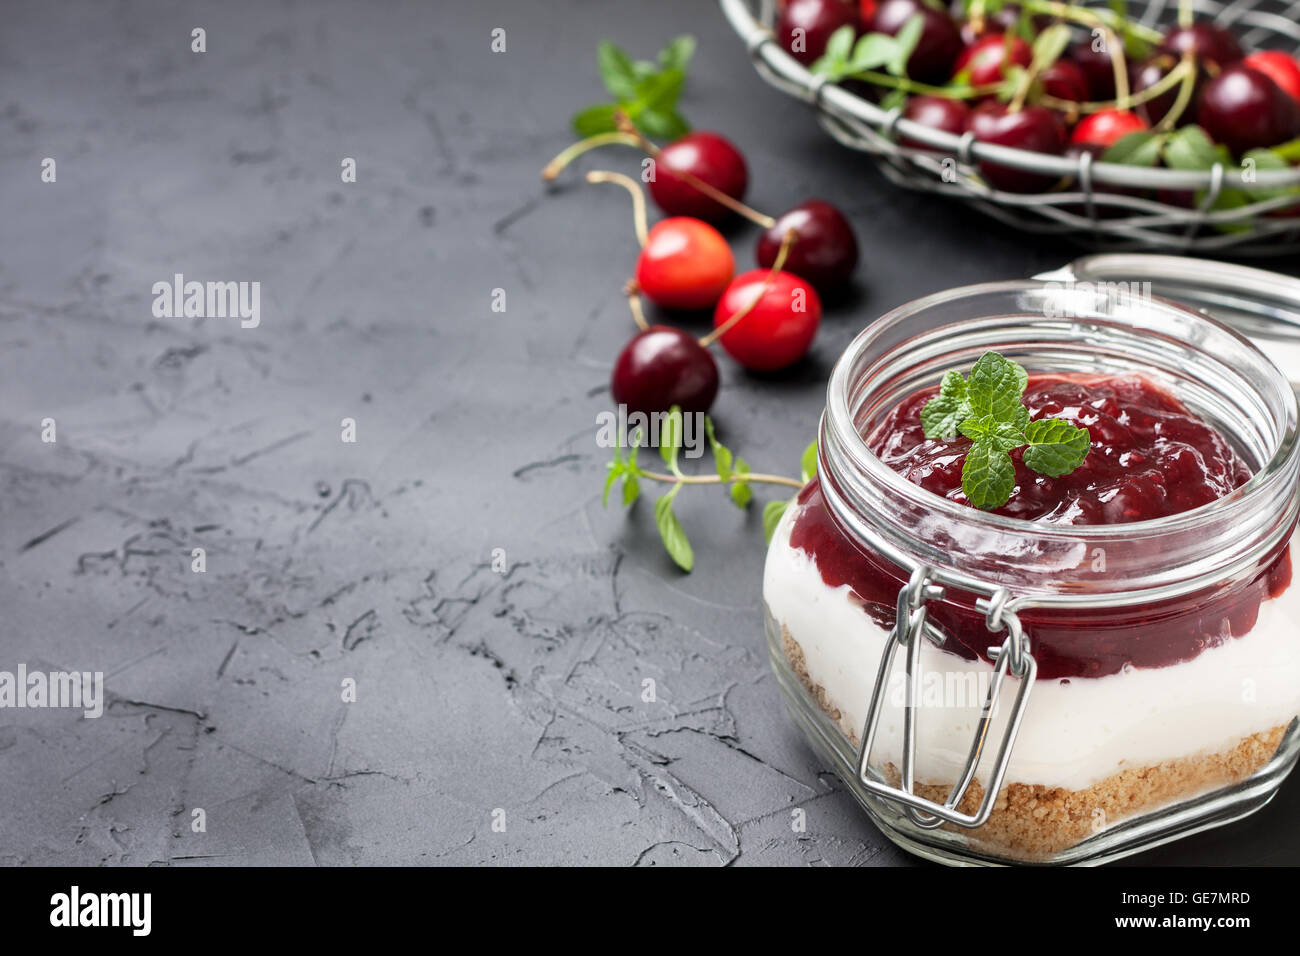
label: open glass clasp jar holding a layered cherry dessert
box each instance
[763,282,1300,864]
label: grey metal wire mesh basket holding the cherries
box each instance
[720,0,1300,256]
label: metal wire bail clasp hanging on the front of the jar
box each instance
[858,566,1037,829]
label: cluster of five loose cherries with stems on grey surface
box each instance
[542,117,858,414]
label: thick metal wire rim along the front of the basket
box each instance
[719,0,1300,191]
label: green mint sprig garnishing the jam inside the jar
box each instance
[920,351,1092,511]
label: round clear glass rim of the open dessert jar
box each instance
[819,280,1300,540]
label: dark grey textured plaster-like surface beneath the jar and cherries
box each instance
[0,0,1300,865]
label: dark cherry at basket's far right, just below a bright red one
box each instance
[1196,64,1300,156]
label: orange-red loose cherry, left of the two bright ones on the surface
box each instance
[636,216,736,308]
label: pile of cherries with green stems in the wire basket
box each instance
[775,0,1300,193]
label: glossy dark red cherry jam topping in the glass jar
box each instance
[790,375,1291,680]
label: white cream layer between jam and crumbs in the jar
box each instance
[763,507,1300,790]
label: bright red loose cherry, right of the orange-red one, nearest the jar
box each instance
[714,269,822,372]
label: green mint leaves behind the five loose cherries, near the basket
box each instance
[573,36,696,139]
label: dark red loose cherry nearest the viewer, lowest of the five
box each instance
[610,325,718,415]
